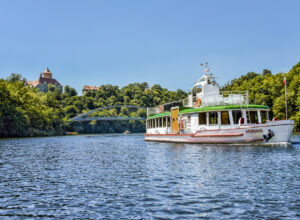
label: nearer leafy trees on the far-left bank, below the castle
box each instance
[0,74,63,137]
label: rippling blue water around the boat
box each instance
[0,135,300,219]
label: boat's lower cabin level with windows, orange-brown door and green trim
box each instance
[146,105,270,134]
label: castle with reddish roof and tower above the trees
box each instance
[27,68,63,92]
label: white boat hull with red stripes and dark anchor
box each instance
[145,120,294,144]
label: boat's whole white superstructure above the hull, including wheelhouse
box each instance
[146,73,270,134]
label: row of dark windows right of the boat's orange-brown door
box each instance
[199,110,267,125]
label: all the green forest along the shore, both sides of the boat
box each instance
[0,62,300,137]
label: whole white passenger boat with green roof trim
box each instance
[144,64,294,144]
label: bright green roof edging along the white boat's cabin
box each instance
[147,105,270,119]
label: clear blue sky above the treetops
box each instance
[0,0,300,93]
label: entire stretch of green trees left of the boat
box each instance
[0,74,186,137]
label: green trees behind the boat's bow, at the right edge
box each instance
[222,62,300,131]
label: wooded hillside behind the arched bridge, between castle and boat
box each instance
[62,83,187,133]
